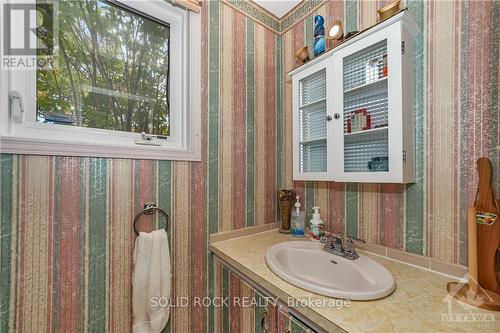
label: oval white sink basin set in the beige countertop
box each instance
[266,241,396,300]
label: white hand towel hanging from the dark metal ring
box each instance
[132,230,171,333]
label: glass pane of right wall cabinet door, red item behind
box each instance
[342,39,390,173]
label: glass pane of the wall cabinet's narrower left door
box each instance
[294,66,328,179]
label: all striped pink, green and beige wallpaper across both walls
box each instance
[0,1,500,332]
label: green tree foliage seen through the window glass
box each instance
[37,0,170,135]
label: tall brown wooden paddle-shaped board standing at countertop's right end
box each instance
[474,157,500,294]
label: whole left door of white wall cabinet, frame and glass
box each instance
[293,58,333,180]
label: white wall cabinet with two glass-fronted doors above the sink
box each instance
[289,12,418,183]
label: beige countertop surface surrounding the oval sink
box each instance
[210,230,500,333]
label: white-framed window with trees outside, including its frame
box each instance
[0,0,200,160]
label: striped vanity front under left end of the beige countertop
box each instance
[214,261,277,333]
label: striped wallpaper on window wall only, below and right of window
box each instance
[0,1,283,333]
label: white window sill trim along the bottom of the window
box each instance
[0,136,201,162]
